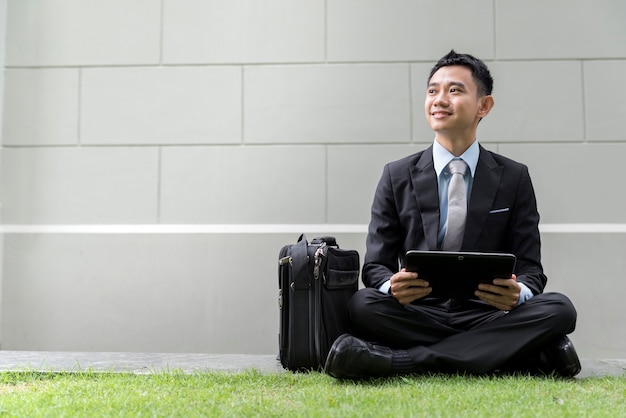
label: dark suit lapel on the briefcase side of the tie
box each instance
[410,145,439,250]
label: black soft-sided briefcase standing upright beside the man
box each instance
[278,234,360,371]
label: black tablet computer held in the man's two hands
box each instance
[406,250,516,299]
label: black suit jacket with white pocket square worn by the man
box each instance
[363,146,547,294]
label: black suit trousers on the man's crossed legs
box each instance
[348,288,576,374]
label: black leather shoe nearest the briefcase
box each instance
[324,334,391,379]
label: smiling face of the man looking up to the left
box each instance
[424,65,488,140]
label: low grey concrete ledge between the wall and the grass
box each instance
[0,351,626,378]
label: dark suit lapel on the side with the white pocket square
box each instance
[461,146,503,249]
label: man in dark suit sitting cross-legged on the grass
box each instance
[325,51,580,379]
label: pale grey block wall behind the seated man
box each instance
[0,0,626,358]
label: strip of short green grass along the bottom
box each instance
[0,371,626,418]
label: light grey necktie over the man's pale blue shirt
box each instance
[443,160,467,251]
